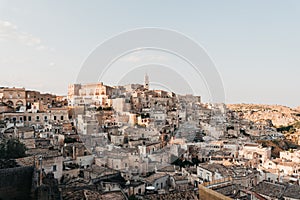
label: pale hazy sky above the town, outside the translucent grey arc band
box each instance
[0,0,300,107]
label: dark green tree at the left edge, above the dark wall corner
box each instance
[0,138,26,159]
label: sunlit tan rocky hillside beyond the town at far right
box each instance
[227,104,300,127]
